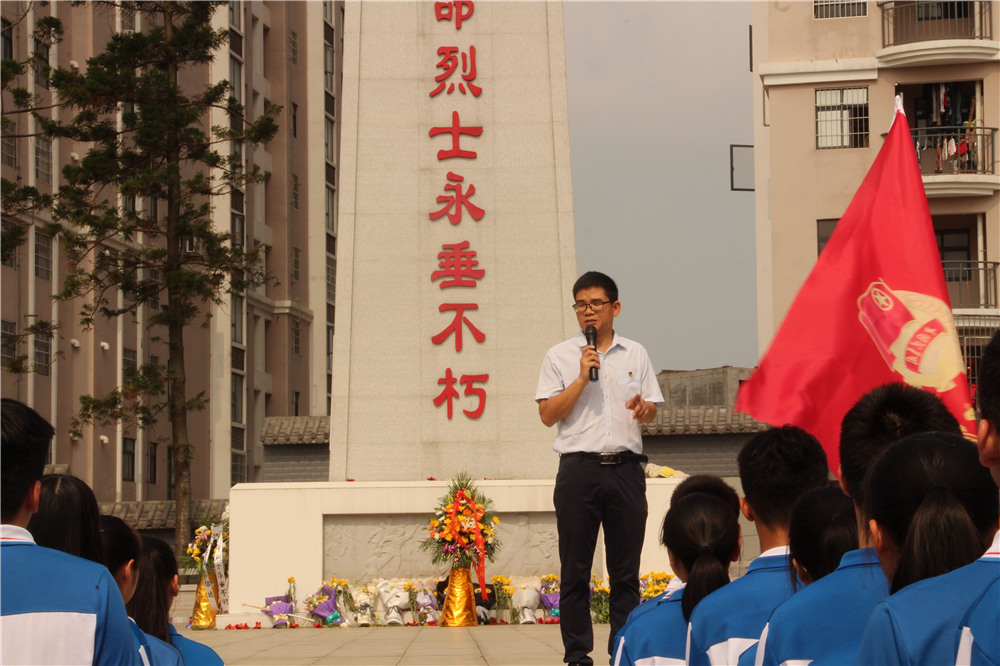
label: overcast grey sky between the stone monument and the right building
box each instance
[563,0,757,372]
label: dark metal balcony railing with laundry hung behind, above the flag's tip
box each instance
[911,126,997,175]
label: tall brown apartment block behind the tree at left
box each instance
[0,0,343,504]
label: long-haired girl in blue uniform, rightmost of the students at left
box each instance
[128,535,223,666]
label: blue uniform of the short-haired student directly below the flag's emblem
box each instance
[756,548,889,666]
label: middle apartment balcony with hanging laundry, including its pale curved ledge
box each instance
[911,126,1000,199]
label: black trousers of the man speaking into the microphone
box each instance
[553,456,647,664]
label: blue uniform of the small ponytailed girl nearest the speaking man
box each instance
[611,588,687,666]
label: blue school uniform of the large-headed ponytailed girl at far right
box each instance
[857,528,1000,665]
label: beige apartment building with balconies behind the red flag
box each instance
[752,0,1000,385]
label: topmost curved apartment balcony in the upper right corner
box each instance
[875,0,1000,67]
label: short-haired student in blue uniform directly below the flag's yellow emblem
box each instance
[757,383,962,666]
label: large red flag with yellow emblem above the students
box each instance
[736,102,976,472]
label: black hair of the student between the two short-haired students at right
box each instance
[788,484,858,589]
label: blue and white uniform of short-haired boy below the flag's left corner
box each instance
[688,546,792,666]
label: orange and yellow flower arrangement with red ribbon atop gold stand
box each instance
[420,472,500,599]
